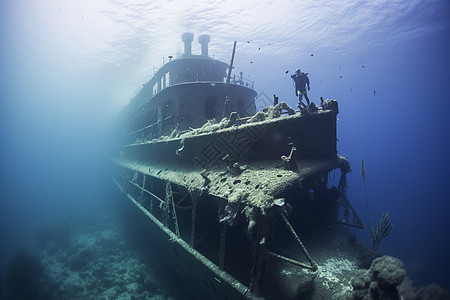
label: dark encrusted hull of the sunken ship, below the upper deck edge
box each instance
[113,103,356,299]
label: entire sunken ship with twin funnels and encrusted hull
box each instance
[111,33,363,299]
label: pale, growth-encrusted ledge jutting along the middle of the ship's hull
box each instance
[114,156,348,208]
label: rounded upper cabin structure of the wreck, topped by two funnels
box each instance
[119,33,256,143]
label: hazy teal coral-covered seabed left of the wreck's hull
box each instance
[29,216,174,300]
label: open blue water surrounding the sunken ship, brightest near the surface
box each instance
[0,0,450,296]
